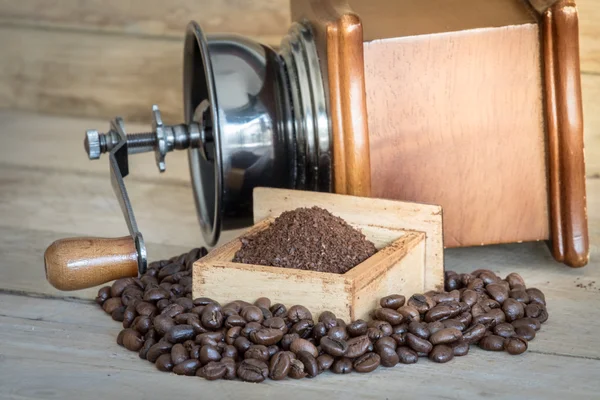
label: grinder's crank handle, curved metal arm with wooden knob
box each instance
[44,118,147,290]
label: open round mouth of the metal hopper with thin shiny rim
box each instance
[183,21,224,246]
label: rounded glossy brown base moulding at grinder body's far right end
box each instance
[543,0,589,267]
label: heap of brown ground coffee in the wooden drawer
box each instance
[233,207,377,274]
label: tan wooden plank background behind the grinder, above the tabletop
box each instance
[0,0,600,177]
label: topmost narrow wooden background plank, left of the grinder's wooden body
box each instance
[0,0,290,45]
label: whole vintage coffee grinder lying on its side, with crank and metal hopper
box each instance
[45,0,589,290]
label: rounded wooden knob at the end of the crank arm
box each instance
[44,236,138,290]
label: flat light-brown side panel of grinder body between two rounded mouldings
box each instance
[365,24,550,247]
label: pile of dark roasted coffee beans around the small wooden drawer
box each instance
[96,249,548,382]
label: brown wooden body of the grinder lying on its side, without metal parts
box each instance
[291,0,589,267]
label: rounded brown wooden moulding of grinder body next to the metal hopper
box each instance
[291,0,371,197]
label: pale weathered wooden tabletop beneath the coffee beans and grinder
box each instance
[0,111,600,399]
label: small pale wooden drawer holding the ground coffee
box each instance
[193,188,444,321]
